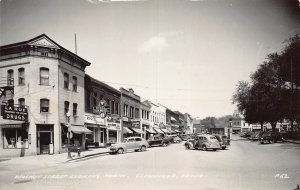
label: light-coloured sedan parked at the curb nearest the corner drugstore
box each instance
[109,137,149,154]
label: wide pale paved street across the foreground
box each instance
[0,135,300,190]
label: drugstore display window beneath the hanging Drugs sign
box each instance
[3,128,29,149]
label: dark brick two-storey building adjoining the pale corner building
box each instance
[84,75,121,146]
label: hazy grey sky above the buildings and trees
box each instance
[0,0,300,118]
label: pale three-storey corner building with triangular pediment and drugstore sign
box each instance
[0,34,90,156]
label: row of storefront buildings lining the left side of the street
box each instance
[0,34,192,157]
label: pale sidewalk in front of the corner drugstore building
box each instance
[0,148,109,168]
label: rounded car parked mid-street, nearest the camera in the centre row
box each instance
[184,135,221,151]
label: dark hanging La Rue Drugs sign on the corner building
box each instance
[1,105,28,121]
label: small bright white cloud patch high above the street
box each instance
[138,36,169,53]
